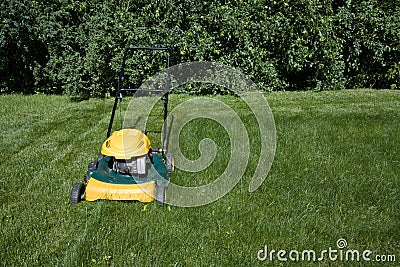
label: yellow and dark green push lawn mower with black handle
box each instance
[70,46,174,205]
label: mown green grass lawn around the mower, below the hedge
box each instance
[0,90,400,266]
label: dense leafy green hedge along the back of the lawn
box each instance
[0,0,400,96]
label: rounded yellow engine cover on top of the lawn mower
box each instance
[101,129,150,159]
